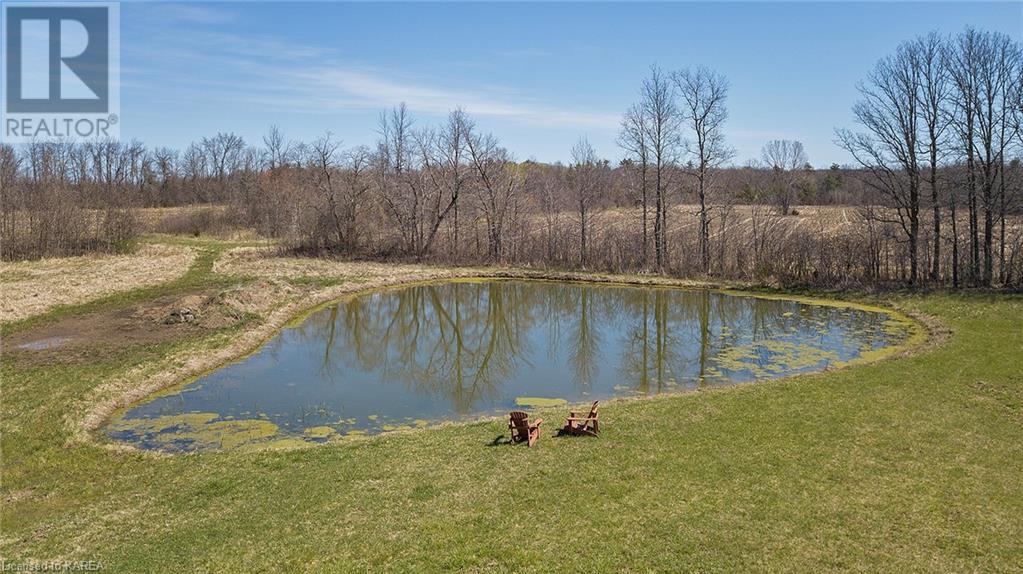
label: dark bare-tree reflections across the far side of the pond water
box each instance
[304,280,908,413]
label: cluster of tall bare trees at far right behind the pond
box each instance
[838,29,1023,285]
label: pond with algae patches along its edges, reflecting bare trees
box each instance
[105,279,915,451]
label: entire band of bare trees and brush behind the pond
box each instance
[0,30,1023,286]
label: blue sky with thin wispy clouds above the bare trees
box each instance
[121,2,1023,166]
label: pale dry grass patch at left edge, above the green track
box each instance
[0,240,195,322]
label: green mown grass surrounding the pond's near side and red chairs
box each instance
[0,236,1023,572]
